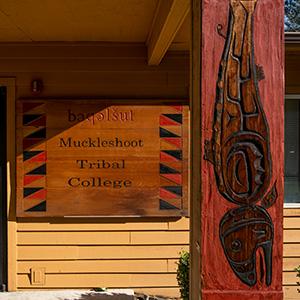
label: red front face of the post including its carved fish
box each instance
[192,0,284,300]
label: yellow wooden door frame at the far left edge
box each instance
[0,77,17,291]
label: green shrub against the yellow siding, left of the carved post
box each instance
[177,251,190,300]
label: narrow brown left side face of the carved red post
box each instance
[190,0,202,300]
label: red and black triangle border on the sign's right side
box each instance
[159,106,183,210]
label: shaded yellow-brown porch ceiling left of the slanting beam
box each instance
[0,0,158,42]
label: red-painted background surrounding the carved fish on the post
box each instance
[201,0,284,300]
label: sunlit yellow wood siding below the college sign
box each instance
[17,218,189,296]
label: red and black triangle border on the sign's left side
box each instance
[22,102,47,212]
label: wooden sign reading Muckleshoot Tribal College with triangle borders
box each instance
[17,100,188,217]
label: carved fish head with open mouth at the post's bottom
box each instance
[220,206,273,286]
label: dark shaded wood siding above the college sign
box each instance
[0,43,189,99]
